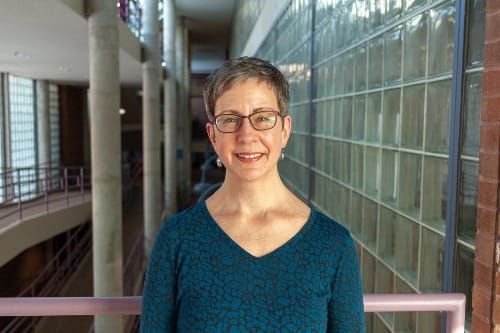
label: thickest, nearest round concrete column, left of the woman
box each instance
[88,0,123,333]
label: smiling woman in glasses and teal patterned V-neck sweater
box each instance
[141,57,365,333]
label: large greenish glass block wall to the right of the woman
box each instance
[235,0,485,332]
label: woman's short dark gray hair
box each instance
[203,57,290,121]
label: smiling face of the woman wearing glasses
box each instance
[206,78,291,181]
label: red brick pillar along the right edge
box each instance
[471,1,500,333]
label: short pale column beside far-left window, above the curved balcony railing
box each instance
[36,80,50,167]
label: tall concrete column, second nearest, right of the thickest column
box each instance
[142,0,161,258]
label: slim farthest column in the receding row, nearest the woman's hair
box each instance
[175,17,188,208]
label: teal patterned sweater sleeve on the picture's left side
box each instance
[140,222,177,333]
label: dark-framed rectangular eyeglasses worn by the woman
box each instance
[214,111,281,133]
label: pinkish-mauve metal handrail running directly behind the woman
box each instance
[0,294,465,333]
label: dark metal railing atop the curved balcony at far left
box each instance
[0,167,91,220]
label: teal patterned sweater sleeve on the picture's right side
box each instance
[328,235,365,333]
